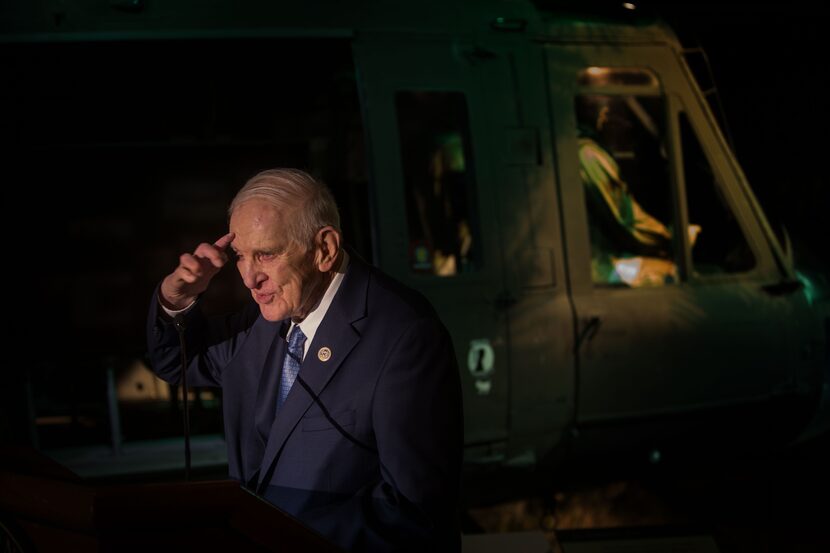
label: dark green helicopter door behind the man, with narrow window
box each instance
[354,35,509,445]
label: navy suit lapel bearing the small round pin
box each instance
[258,252,368,493]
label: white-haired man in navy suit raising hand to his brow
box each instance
[148,169,463,551]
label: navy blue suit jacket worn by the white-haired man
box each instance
[148,255,463,551]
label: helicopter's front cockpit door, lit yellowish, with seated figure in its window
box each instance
[547,46,790,426]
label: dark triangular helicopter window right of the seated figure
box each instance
[680,112,755,275]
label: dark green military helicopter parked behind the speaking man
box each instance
[0,0,828,504]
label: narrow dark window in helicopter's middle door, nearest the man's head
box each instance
[395,91,481,276]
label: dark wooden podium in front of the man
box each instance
[0,448,342,553]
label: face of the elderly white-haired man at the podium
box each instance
[230,199,322,321]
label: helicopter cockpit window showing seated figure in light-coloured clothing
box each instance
[575,67,678,287]
